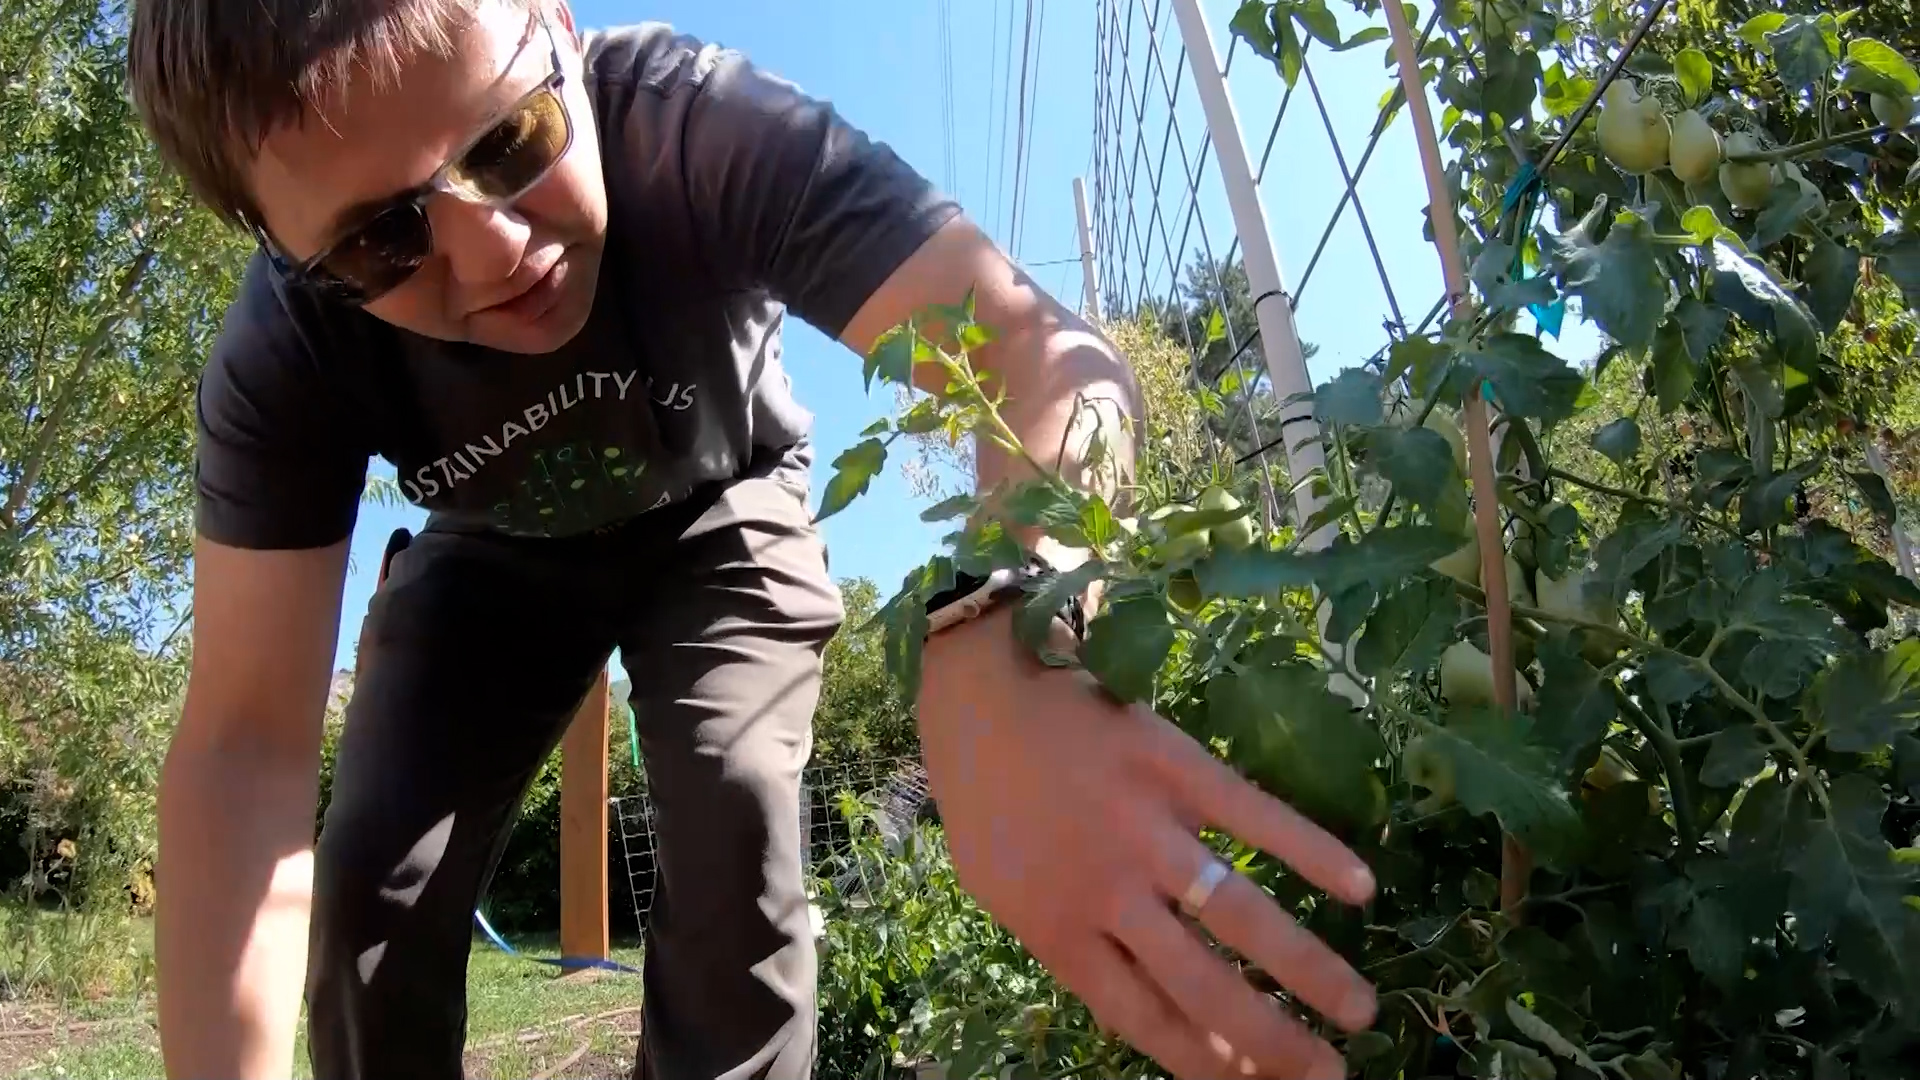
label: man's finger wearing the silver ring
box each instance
[1152,828,1377,1032]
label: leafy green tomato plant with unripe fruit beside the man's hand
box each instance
[824,0,1920,1080]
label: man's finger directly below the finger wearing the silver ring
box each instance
[1121,890,1346,1080]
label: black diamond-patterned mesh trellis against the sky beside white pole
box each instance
[1091,0,1444,513]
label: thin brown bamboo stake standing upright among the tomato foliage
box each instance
[1382,0,1532,917]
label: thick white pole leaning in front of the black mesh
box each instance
[1173,0,1338,552]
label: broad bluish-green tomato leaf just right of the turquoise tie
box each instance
[1540,198,1668,350]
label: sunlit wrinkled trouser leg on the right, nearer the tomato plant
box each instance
[620,470,843,1080]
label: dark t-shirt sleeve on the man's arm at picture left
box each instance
[194,256,369,550]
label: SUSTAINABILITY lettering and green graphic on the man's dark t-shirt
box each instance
[401,369,697,536]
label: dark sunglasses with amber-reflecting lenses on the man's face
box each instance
[253,17,574,304]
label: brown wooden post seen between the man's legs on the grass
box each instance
[561,669,609,959]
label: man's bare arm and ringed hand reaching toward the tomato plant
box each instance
[841,219,1375,1080]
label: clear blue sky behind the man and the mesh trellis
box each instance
[336,0,1594,667]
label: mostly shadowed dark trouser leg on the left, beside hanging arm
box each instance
[307,530,612,1080]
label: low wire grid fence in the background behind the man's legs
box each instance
[609,757,929,928]
